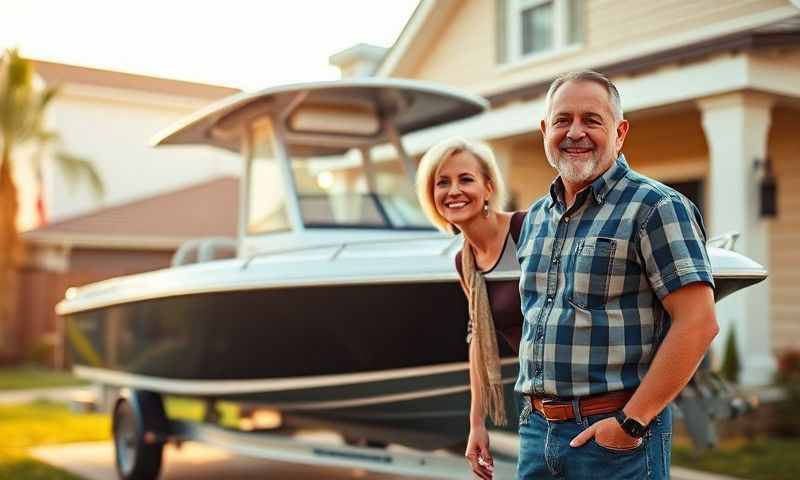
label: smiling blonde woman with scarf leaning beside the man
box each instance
[416,138,525,479]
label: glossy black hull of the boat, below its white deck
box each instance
[66,281,517,448]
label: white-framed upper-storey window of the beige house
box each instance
[501,0,585,62]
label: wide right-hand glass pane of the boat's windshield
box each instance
[291,145,432,230]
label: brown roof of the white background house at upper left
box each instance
[33,60,240,100]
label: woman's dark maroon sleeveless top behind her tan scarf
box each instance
[456,212,526,353]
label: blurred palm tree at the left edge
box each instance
[0,49,103,356]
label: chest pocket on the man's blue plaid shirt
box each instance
[570,237,617,309]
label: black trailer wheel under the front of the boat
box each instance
[112,392,167,480]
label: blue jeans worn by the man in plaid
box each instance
[517,401,672,480]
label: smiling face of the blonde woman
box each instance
[433,151,492,226]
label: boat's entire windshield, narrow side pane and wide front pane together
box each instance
[247,119,433,235]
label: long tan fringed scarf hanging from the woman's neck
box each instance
[461,241,506,426]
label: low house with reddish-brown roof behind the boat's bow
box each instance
[18,177,239,366]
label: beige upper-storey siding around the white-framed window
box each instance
[404,0,790,94]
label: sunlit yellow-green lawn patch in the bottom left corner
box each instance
[0,402,111,480]
